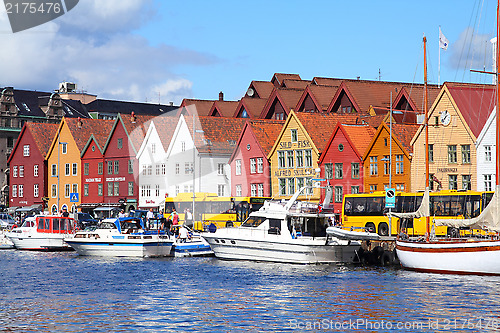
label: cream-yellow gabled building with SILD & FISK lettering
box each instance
[267,110,356,202]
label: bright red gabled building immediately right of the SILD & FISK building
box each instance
[318,123,376,213]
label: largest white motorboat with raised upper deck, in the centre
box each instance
[202,188,361,264]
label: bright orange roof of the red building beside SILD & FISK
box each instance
[319,123,376,163]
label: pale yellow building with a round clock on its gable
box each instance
[411,82,495,191]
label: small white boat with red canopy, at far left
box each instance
[7,215,76,251]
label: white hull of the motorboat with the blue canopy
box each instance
[66,238,173,257]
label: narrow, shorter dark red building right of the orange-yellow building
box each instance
[78,120,115,212]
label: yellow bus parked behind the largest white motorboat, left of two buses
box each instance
[163,192,271,231]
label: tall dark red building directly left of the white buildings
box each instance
[99,114,153,211]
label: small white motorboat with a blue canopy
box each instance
[65,217,174,257]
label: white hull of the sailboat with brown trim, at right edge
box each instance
[396,240,500,275]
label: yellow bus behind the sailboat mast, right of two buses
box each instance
[341,190,486,236]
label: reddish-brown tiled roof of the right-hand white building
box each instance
[185,116,246,155]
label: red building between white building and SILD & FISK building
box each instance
[228,119,284,197]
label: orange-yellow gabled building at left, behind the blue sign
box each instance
[47,118,108,213]
